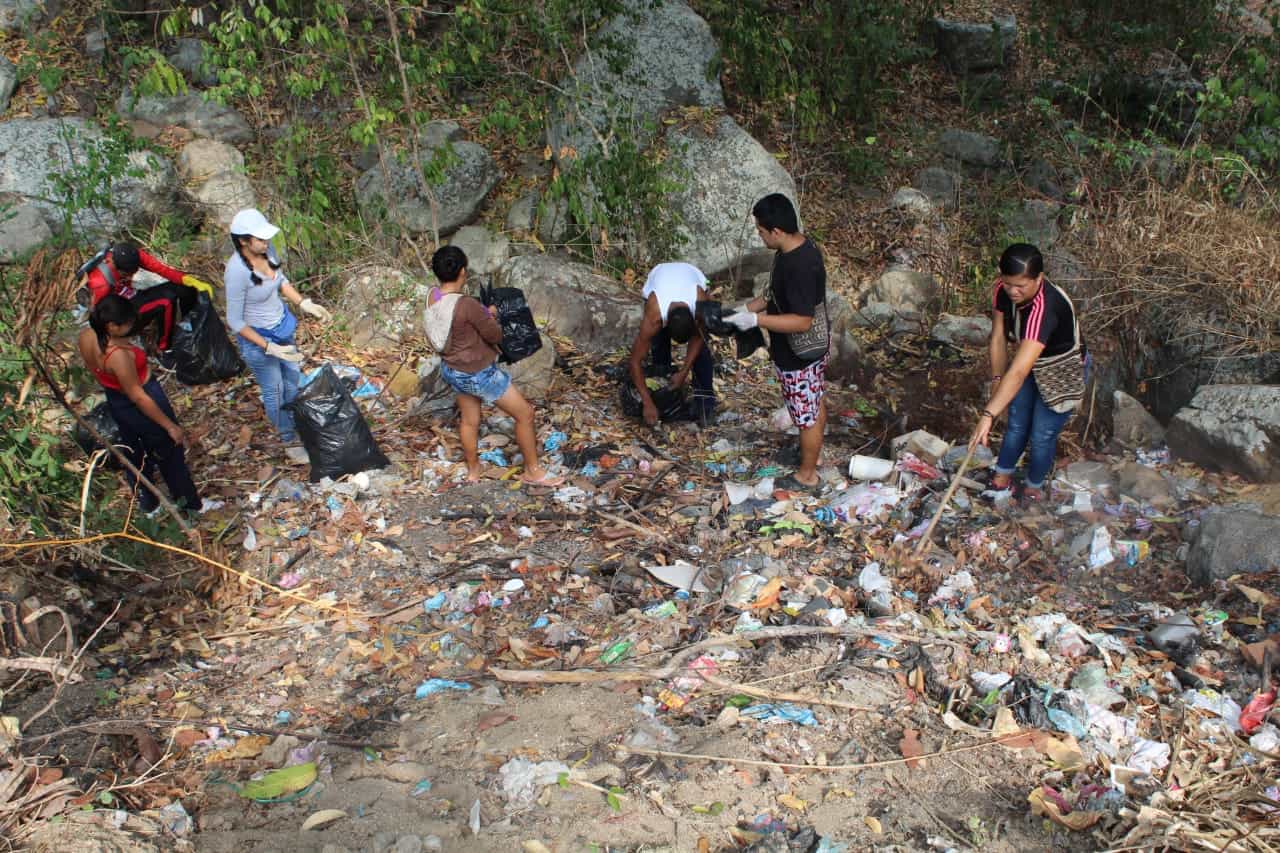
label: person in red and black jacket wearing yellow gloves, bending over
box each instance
[87,241,214,366]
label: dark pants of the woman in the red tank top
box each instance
[106,378,200,512]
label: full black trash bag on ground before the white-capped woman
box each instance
[284,365,390,483]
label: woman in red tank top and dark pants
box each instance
[79,293,221,514]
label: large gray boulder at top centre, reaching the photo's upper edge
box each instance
[548,0,724,160]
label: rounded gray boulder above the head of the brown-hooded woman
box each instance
[356,122,502,237]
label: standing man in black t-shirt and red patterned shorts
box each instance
[726,192,829,489]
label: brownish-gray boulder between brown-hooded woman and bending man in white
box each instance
[495,255,644,355]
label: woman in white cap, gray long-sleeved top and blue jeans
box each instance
[223,207,333,462]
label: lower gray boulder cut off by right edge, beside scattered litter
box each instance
[1187,506,1280,584]
